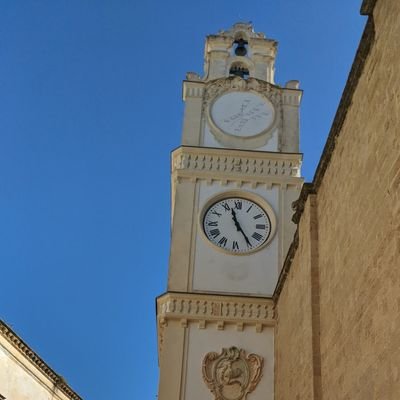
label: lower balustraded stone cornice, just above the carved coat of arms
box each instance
[156,292,275,352]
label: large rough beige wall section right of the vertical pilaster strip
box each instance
[318,0,400,400]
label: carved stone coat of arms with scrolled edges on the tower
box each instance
[202,347,264,400]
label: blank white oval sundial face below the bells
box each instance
[211,92,275,137]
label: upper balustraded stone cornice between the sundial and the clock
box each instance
[172,146,303,186]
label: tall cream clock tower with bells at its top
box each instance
[157,23,303,400]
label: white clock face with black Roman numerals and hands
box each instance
[203,197,271,254]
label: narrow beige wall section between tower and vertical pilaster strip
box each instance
[275,195,313,400]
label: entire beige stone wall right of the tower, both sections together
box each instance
[276,0,400,400]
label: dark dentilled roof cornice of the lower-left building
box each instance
[0,320,82,400]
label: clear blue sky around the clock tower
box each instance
[0,0,365,400]
